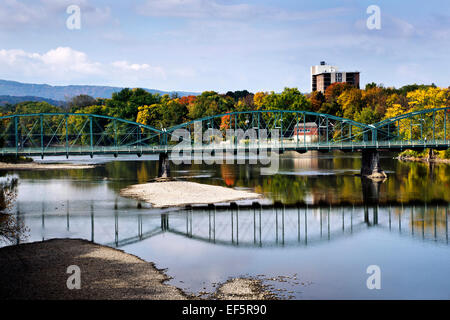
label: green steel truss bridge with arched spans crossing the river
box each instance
[0,107,450,157]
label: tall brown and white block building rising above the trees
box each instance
[311,61,359,93]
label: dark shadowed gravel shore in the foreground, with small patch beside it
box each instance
[0,239,274,300]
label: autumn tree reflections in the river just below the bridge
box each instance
[10,153,450,205]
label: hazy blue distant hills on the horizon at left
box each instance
[0,80,198,101]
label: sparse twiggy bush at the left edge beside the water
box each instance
[0,176,26,242]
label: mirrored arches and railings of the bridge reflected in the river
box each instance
[17,202,450,248]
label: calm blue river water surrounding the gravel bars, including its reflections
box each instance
[1,153,450,299]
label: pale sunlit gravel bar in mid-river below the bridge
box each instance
[120,181,261,208]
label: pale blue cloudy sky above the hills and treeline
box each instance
[0,0,450,93]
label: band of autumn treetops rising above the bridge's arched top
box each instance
[1,83,450,157]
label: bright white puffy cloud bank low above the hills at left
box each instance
[0,47,166,85]
